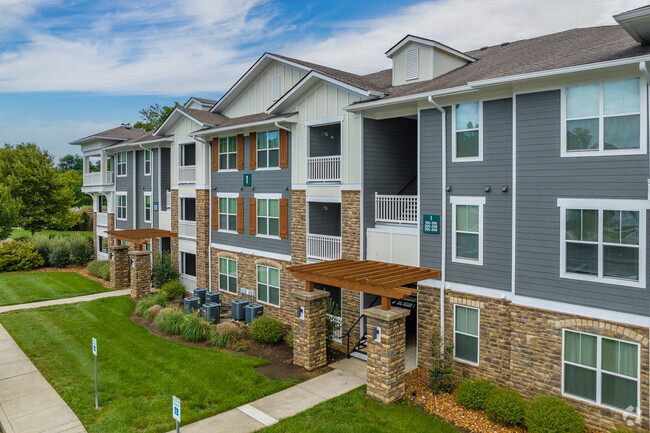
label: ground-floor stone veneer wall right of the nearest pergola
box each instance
[418,286,649,430]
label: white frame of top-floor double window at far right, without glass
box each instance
[560,77,648,158]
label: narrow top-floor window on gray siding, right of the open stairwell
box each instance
[452,102,483,161]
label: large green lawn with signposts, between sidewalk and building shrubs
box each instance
[0,296,291,432]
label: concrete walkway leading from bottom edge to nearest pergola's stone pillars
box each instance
[170,359,366,433]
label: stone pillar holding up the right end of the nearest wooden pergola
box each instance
[364,307,409,404]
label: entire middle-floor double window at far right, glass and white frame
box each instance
[558,199,646,287]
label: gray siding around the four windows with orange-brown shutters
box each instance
[212,134,292,255]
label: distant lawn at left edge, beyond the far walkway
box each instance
[0,272,108,305]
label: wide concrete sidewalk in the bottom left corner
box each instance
[0,325,86,433]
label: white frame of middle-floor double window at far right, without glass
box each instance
[557,198,648,288]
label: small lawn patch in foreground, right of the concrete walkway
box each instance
[260,386,458,433]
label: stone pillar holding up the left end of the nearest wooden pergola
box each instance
[291,290,329,370]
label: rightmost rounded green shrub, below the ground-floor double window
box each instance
[525,395,585,433]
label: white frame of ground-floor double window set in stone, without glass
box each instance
[562,328,643,416]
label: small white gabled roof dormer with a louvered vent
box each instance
[386,35,476,86]
